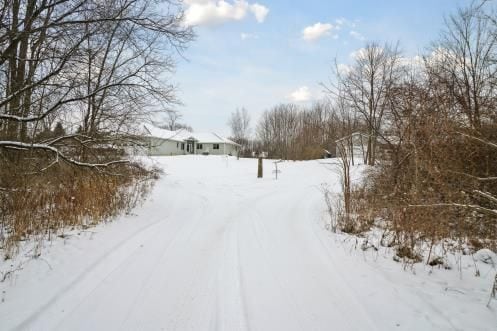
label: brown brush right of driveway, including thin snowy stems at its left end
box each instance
[325,119,497,263]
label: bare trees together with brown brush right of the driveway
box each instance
[328,2,497,256]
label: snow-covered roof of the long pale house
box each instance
[143,124,238,145]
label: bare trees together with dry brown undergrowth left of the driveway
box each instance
[0,0,193,255]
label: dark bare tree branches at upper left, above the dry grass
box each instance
[0,0,192,164]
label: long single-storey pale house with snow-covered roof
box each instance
[142,124,240,156]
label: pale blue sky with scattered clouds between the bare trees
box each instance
[170,0,469,134]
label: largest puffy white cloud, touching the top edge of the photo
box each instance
[184,0,269,26]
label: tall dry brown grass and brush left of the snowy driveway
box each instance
[0,154,156,258]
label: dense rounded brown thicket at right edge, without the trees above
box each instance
[352,120,497,255]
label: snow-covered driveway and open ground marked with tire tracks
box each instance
[0,156,497,330]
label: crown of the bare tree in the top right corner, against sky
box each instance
[427,1,497,130]
